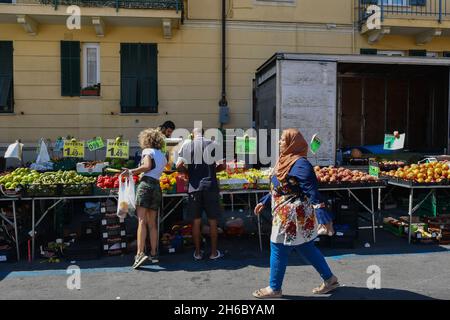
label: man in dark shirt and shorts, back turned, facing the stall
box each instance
[177,128,224,261]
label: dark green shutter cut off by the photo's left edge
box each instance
[0,41,14,112]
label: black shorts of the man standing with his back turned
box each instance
[188,191,222,220]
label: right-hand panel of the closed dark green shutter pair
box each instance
[139,44,158,113]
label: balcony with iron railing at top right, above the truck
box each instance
[356,0,450,45]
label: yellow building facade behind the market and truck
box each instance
[0,0,450,144]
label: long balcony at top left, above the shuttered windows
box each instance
[0,0,186,38]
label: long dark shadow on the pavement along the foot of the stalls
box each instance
[0,230,450,282]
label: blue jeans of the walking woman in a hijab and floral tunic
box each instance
[270,241,333,291]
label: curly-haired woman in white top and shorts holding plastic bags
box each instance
[125,129,167,269]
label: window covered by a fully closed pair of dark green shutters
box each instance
[120,43,158,113]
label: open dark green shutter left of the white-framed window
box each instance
[61,41,81,97]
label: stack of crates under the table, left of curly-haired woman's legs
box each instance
[101,200,127,256]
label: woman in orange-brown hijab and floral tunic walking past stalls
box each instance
[253,129,339,299]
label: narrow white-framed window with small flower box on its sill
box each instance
[81,43,100,96]
